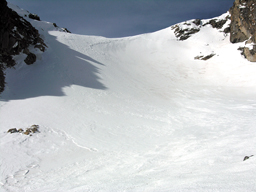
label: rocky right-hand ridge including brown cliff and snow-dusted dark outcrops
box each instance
[172,0,256,62]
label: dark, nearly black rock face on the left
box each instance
[0,0,46,93]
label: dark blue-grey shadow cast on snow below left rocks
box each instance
[0,32,106,101]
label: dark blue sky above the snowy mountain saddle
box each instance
[7,0,234,37]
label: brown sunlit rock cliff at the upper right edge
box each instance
[229,0,256,62]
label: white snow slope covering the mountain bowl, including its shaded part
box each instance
[0,5,256,192]
